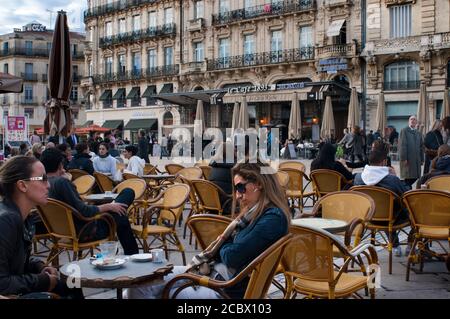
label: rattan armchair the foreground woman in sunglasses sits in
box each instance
[163,234,292,299]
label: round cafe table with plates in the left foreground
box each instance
[60,256,173,299]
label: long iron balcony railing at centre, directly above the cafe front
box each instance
[207,47,314,71]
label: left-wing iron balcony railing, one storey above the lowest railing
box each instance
[99,23,176,49]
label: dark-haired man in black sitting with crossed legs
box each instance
[41,149,139,255]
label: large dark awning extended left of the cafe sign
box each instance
[153,89,226,106]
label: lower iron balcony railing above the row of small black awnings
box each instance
[93,64,180,84]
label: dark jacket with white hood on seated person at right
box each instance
[353,165,410,196]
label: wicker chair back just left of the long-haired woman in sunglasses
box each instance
[186,214,233,250]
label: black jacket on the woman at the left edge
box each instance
[0,200,50,295]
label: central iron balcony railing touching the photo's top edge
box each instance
[212,0,316,25]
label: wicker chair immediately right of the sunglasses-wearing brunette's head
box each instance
[280,168,315,213]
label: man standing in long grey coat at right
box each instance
[398,115,423,186]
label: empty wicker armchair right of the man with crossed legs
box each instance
[131,184,189,265]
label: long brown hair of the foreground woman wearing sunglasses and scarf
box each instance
[232,162,291,223]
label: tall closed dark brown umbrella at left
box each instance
[44,11,72,136]
